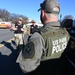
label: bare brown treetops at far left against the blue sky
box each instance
[0,9,27,23]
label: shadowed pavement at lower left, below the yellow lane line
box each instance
[0,41,26,75]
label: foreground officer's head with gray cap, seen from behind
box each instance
[38,0,60,24]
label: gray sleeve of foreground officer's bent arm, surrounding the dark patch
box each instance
[17,32,44,72]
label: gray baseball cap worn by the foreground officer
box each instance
[38,0,60,14]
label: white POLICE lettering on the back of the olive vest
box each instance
[52,37,67,55]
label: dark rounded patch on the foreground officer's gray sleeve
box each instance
[22,42,35,59]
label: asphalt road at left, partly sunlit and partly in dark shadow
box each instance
[0,29,26,75]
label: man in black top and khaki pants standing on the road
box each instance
[13,17,27,49]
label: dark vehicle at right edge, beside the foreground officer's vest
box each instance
[60,19,75,75]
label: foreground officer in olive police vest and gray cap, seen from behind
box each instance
[17,0,69,75]
